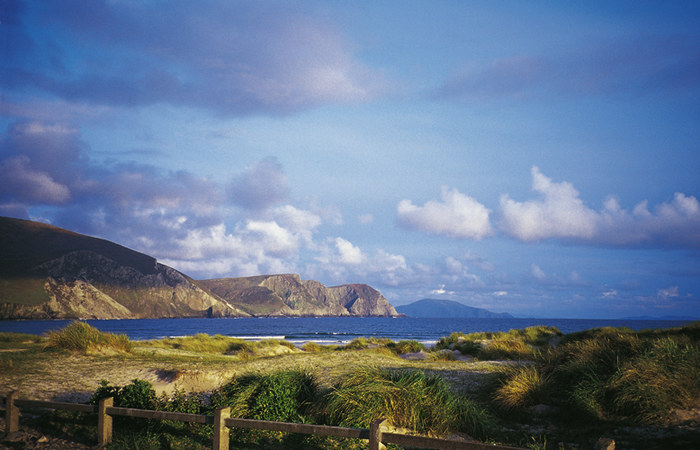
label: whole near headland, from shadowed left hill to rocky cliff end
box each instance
[0,217,398,319]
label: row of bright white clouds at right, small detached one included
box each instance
[397,166,700,248]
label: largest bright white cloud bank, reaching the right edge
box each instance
[499,167,700,248]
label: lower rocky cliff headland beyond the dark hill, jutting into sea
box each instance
[199,274,398,316]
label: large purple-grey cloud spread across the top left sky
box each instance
[2,0,382,114]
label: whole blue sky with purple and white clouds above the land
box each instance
[0,0,700,318]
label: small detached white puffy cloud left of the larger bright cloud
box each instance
[396,187,492,241]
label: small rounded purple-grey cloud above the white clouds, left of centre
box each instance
[227,157,289,210]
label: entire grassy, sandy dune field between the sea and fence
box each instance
[0,322,700,449]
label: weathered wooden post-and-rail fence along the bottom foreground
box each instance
[0,391,515,450]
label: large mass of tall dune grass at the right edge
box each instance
[493,326,700,424]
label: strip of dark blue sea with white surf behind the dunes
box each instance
[0,317,689,345]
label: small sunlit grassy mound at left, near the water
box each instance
[44,321,133,352]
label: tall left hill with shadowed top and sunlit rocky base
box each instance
[0,217,248,319]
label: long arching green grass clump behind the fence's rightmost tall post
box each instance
[326,367,491,435]
